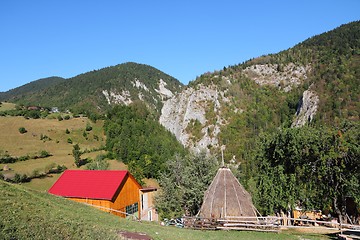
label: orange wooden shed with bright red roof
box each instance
[49,170,142,218]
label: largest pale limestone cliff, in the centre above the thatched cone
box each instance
[159,85,225,150]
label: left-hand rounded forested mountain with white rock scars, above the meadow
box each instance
[2,62,183,113]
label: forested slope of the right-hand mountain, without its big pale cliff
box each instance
[189,21,360,161]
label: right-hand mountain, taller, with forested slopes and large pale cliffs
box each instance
[160,21,360,159]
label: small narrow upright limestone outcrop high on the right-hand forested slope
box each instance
[291,90,319,127]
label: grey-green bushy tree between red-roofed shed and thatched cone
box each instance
[155,152,218,218]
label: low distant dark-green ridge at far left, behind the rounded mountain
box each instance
[0,77,65,101]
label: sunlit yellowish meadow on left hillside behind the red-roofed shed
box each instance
[0,115,126,191]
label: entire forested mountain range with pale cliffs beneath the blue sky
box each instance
[2,21,360,162]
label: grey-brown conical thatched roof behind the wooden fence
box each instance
[198,167,257,219]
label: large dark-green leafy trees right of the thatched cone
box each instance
[248,122,360,219]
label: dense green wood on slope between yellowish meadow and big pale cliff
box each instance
[104,102,186,178]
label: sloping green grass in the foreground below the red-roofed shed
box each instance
[0,181,329,240]
